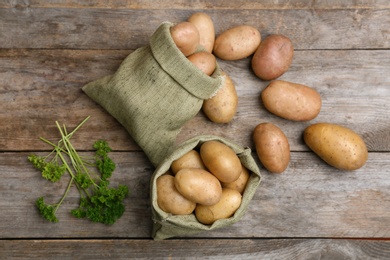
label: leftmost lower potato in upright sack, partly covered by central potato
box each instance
[156,175,196,215]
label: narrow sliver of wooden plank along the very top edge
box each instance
[0,0,389,10]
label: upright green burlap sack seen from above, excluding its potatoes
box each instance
[150,135,261,240]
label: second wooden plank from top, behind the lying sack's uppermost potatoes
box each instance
[0,7,390,49]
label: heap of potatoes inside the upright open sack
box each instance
[156,140,250,225]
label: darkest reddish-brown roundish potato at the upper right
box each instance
[252,34,294,80]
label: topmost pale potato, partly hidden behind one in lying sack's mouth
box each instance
[188,12,215,53]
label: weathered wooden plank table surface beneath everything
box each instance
[0,0,390,259]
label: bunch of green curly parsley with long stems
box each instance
[28,117,128,225]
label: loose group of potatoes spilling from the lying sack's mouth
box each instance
[171,12,368,173]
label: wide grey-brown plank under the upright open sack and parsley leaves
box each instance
[0,152,390,239]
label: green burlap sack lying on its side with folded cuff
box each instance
[82,22,223,166]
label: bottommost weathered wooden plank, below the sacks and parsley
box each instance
[0,239,390,260]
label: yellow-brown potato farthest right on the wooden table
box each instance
[303,123,368,170]
